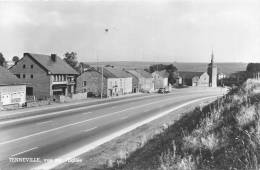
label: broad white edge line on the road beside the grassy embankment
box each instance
[32,96,217,170]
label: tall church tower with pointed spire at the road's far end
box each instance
[208,50,218,87]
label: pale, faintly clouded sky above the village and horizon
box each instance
[0,0,260,62]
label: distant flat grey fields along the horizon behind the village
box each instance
[87,61,247,75]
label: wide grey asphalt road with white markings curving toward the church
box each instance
[0,88,224,170]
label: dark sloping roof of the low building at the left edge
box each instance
[0,66,25,86]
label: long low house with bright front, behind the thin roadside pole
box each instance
[77,67,132,97]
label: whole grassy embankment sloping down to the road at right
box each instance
[105,80,260,170]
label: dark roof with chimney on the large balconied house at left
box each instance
[24,53,78,74]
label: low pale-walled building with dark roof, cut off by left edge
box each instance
[0,66,26,109]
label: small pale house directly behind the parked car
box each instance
[152,70,169,89]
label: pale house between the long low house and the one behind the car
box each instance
[128,69,154,92]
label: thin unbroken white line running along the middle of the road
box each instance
[0,95,191,145]
